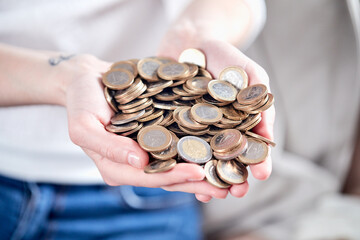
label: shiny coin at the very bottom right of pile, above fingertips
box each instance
[216,160,248,184]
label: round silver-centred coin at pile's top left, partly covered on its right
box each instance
[137,58,162,82]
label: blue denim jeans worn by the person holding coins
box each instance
[0,176,202,240]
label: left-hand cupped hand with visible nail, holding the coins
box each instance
[64,55,204,187]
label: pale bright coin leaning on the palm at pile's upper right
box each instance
[219,66,249,90]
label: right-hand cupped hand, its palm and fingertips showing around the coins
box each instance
[159,39,275,202]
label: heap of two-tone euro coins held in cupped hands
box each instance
[103,49,275,188]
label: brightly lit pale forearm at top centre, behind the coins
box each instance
[160,0,265,55]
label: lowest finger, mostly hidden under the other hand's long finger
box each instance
[162,181,228,199]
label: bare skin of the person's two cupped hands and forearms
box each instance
[0,0,275,202]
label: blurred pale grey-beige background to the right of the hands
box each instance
[204,0,360,239]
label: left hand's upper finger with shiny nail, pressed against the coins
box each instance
[69,114,149,168]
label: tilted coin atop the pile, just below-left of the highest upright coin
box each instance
[157,62,190,80]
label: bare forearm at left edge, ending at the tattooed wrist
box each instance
[0,44,69,106]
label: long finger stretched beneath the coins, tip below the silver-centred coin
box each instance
[87,156,205,187]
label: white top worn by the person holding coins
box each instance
[0,0,264,184]
